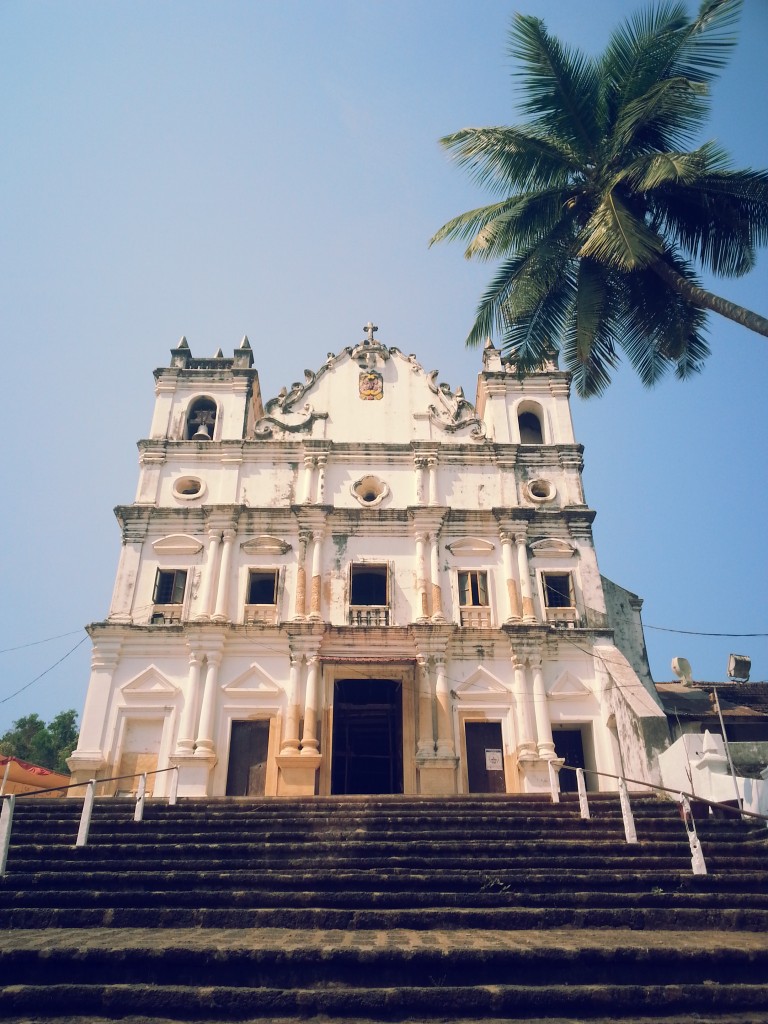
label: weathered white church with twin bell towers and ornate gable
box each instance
[70,324,667,797]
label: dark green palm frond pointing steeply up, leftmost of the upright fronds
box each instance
[509,14,603,159]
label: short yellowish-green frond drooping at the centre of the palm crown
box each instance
[579,189,664,270]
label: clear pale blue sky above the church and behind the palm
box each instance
[0,0,768,731]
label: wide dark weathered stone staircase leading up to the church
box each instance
[0,796,768,1024]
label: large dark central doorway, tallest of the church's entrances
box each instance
[331,679,402,794]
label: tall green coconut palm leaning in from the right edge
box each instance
[430,0,768,396]
